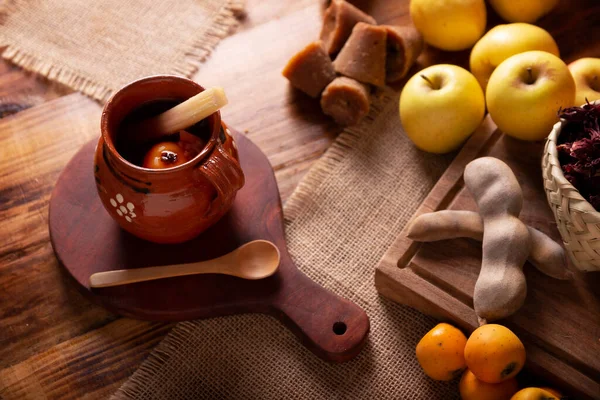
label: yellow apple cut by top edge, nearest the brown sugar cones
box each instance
[410,0,486,51]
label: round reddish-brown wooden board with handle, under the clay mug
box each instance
[49,131,369,362]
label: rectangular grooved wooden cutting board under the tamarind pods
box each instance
[375,116,600,399]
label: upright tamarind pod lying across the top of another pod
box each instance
[464,157,531,322]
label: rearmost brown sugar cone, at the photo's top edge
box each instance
[321,0,377,54]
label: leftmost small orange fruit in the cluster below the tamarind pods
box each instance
[416,323,467,381]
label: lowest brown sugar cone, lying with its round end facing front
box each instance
[321,76,370,126]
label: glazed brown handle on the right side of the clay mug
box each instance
[200,143,244,218]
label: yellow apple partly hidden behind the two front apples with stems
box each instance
[469,22,560,90]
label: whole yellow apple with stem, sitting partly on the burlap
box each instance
[400,64,485,153]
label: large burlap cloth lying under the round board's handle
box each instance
[113,95,459,400]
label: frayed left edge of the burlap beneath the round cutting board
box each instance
[111,91,392,400]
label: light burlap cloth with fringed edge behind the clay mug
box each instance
[0,0,244,102]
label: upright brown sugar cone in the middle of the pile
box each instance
[333,22,387,87]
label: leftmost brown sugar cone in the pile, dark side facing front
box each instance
[282,40,336,98]
